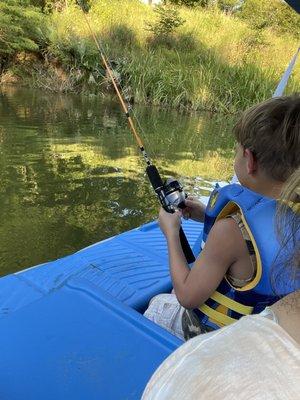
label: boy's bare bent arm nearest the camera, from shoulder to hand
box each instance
[159,209,249,308]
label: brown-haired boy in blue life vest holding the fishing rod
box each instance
[145,95,300,339]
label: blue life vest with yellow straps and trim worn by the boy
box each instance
[194,184,293,329]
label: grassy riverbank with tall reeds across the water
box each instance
[1,0,300,113]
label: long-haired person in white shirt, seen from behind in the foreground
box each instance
[142,169,300,400]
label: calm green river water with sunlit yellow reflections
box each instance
[0,87,234,275]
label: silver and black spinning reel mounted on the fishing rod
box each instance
[155,178,187,213]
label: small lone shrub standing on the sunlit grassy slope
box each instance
[148,5,185,36]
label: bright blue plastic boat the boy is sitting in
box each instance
[0,221,202,400]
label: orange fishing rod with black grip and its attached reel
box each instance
[77,0,195,264]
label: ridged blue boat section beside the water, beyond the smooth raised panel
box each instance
[0,221,203,318]
